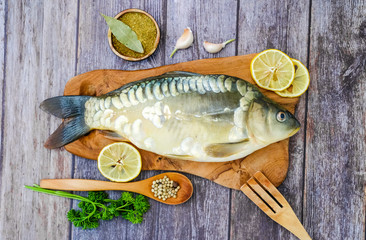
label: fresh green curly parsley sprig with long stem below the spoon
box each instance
[25,184,150,229]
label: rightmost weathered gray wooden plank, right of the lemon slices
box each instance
[304,0,366,239]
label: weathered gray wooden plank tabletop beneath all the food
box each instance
[0,0,366,239]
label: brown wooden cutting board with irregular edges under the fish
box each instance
[64,54,298,189]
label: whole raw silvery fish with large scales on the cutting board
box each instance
[42,72,299,162]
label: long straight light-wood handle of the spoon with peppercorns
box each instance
[40,179,140,193]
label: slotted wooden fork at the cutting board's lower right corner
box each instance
[240,171,311,240]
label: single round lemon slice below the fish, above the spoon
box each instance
[98,142,142,182]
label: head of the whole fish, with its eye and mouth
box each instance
[247,98,300,144]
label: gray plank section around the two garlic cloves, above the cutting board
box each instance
[165,0,237,64]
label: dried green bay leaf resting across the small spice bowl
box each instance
[101,13,144,53]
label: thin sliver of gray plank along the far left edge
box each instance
[0,0,7,191]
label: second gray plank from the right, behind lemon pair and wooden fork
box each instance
[230,1,309,239]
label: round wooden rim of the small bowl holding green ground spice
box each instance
[108,8,160,62]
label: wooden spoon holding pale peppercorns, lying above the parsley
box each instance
[40,172,193,205]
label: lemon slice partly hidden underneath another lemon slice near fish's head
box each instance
[276,59,310,97]
